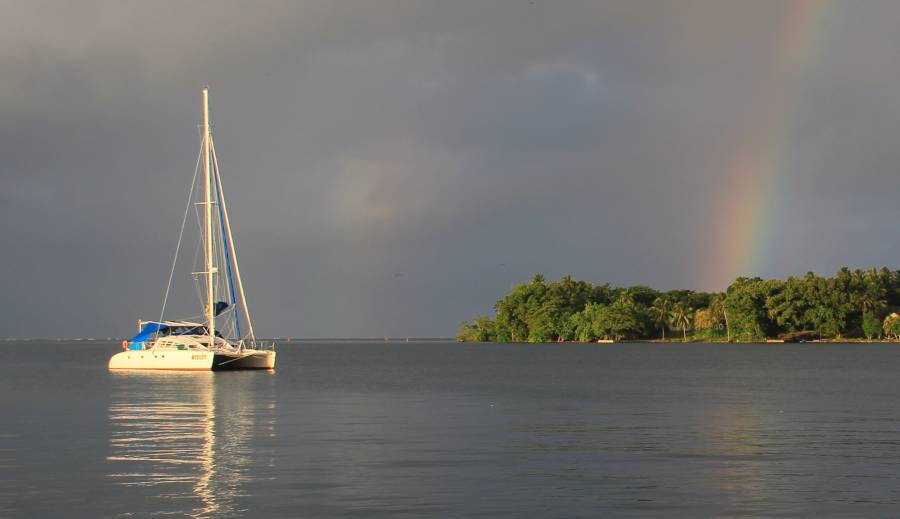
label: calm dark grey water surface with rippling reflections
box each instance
[0,342,900,518]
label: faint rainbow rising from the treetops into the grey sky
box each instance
[702,0,838,290]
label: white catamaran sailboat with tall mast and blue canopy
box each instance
[109,88,275,371]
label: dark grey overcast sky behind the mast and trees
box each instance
[0,0,900,337]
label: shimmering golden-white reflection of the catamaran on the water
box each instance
[107,372,274,517]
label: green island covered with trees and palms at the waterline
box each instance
[457,267,900,342]
